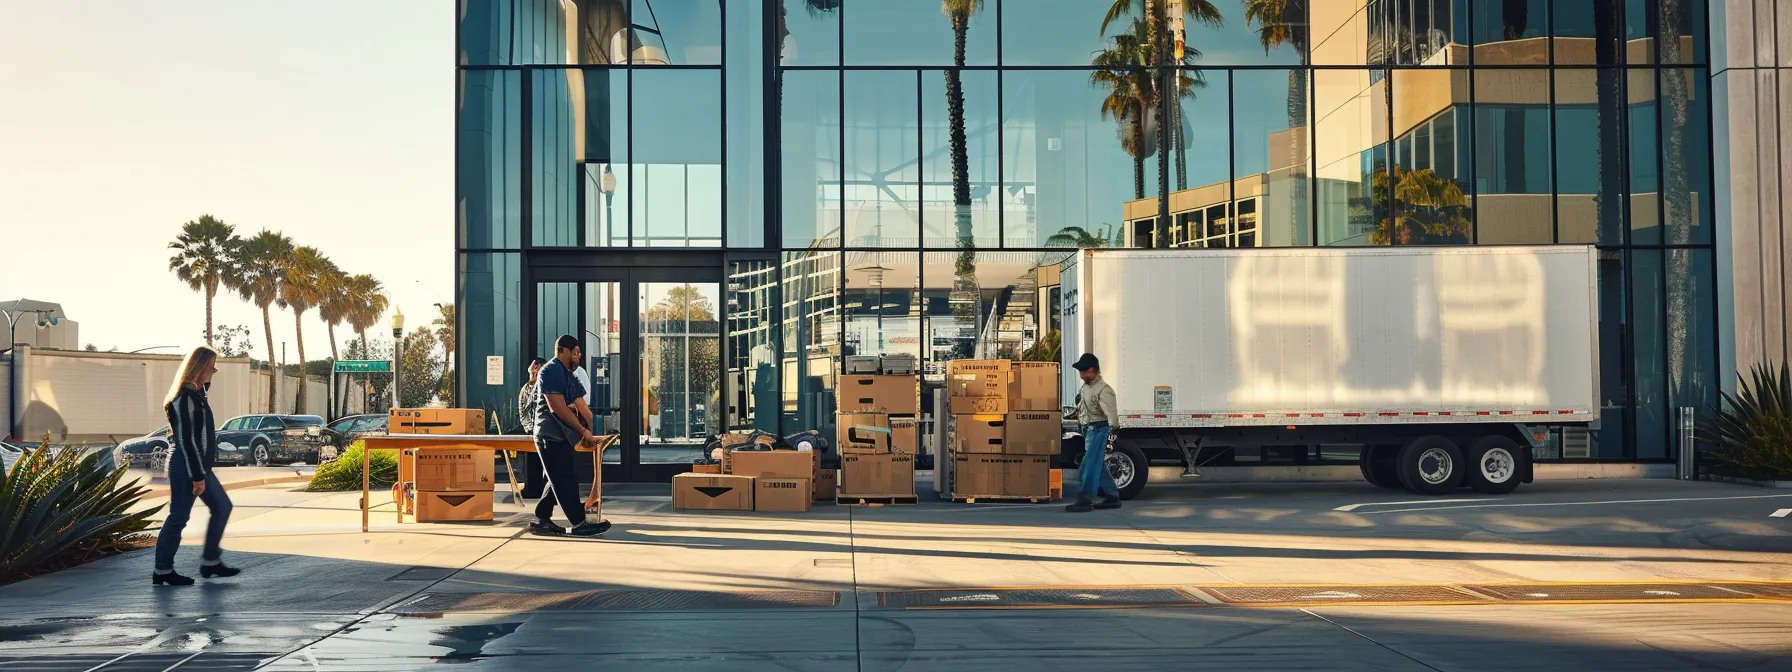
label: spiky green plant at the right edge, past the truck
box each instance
[1699,364,1792,480]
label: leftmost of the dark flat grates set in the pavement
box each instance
[878,588,1206,609]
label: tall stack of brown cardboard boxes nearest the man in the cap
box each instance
[935,360,1063,498]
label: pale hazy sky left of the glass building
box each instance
[0,0,455,360]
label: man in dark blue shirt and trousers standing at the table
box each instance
[529,335,609,536]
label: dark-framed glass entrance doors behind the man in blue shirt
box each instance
[534,269,726,482]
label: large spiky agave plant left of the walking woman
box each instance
[0,442,161,579]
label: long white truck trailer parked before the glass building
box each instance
[1063,246,1600,496]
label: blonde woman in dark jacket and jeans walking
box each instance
[151,346,242,586]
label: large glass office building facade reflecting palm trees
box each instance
[455,0,1727,480]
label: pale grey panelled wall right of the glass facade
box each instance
[1711,0,1792,389]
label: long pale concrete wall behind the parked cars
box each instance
[0,348,362,443]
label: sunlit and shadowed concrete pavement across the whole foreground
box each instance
[0,480,1792,670]
